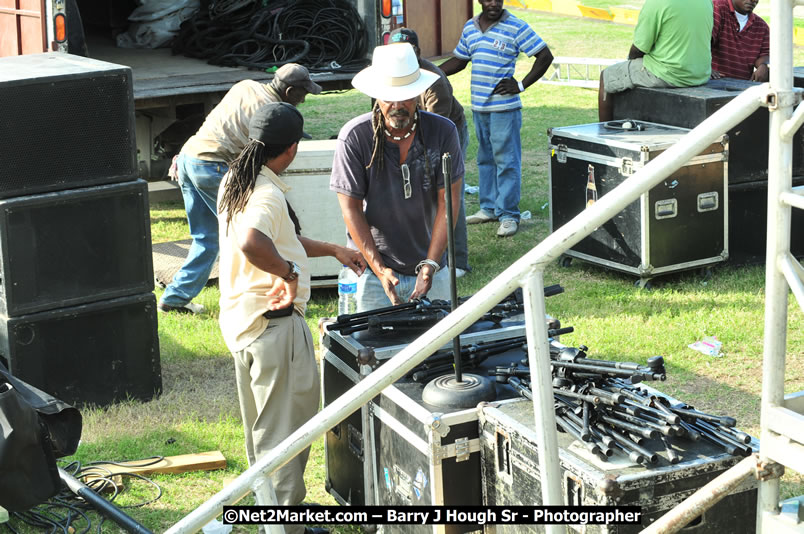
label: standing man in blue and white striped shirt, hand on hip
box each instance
[441,0,553,237]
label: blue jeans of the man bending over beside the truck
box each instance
[161,155,229,306]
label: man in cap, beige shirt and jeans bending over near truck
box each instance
[158,67,321,313]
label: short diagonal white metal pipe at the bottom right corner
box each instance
[642,454,758,534]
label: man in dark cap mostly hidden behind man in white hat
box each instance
[388,28,472,278]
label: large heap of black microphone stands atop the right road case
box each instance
[489,343,752,466]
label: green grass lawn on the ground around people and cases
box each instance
[7,4,804,532]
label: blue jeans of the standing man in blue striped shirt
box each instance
[472,109,522,222]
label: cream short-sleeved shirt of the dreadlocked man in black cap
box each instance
[218,167,310,352]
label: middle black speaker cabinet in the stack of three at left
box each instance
[0,180,154,317]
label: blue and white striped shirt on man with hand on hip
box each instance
[452,10,547,111]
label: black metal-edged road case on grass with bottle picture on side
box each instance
[548,121,729,285]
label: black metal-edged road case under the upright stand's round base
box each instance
[368,338,527,534]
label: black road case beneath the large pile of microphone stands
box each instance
[478,400,759,534]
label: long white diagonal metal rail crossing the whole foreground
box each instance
[166,84,767,534]
